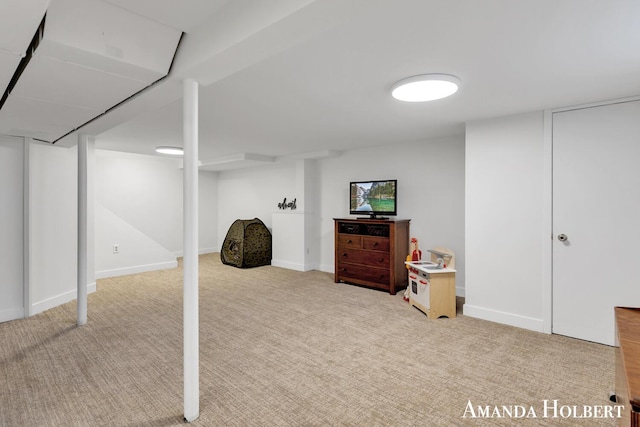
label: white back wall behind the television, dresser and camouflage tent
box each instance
[218,135,465,295]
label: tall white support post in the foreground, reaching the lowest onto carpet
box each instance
[182,79,200,422]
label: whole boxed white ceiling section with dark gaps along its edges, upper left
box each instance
[0,0,182,142]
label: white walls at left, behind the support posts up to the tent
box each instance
[0,144,218,321]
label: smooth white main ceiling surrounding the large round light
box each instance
[0,0,640,170]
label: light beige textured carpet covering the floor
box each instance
[0,254,615,427]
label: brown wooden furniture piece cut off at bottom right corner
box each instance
[615,307,640,427]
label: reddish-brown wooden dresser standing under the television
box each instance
[334,218,410,295]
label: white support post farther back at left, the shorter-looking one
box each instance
[77,135,89,326]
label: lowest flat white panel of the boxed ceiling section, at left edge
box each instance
[0,96,99,142]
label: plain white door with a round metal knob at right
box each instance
[552,101,640,345]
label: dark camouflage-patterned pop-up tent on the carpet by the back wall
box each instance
[220,218,271,268]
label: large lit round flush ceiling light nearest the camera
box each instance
[391,74,460,102]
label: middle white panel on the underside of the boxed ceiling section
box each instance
[12,55,153,111]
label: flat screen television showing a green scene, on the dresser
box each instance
[349,179,398,219]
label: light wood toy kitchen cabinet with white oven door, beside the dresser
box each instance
[405,261,456,319]
